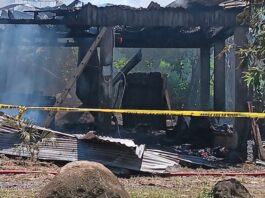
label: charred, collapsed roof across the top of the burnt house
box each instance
[0,0,245,48]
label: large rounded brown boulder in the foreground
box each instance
[38,161,129,198]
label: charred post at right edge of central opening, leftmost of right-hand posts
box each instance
[200,47,210,110]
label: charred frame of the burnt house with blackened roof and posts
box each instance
[0,0,258,172]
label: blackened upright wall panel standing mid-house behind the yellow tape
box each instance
[122,72,166,129]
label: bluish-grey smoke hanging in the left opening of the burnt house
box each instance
[0,25,58,124]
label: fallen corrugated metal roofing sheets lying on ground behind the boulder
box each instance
[0,116,218,173]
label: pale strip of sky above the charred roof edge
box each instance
[64,0,174,7]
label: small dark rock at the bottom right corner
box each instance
[213,179,252,198]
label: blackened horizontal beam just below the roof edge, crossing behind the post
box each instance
[0,27,231,48]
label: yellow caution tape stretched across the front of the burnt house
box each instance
[0,104,265,118]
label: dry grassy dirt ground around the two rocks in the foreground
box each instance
[0,157,265,198]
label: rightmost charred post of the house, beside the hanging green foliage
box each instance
[234,26,250,160]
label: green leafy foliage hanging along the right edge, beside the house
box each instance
[237,0,265,111]
